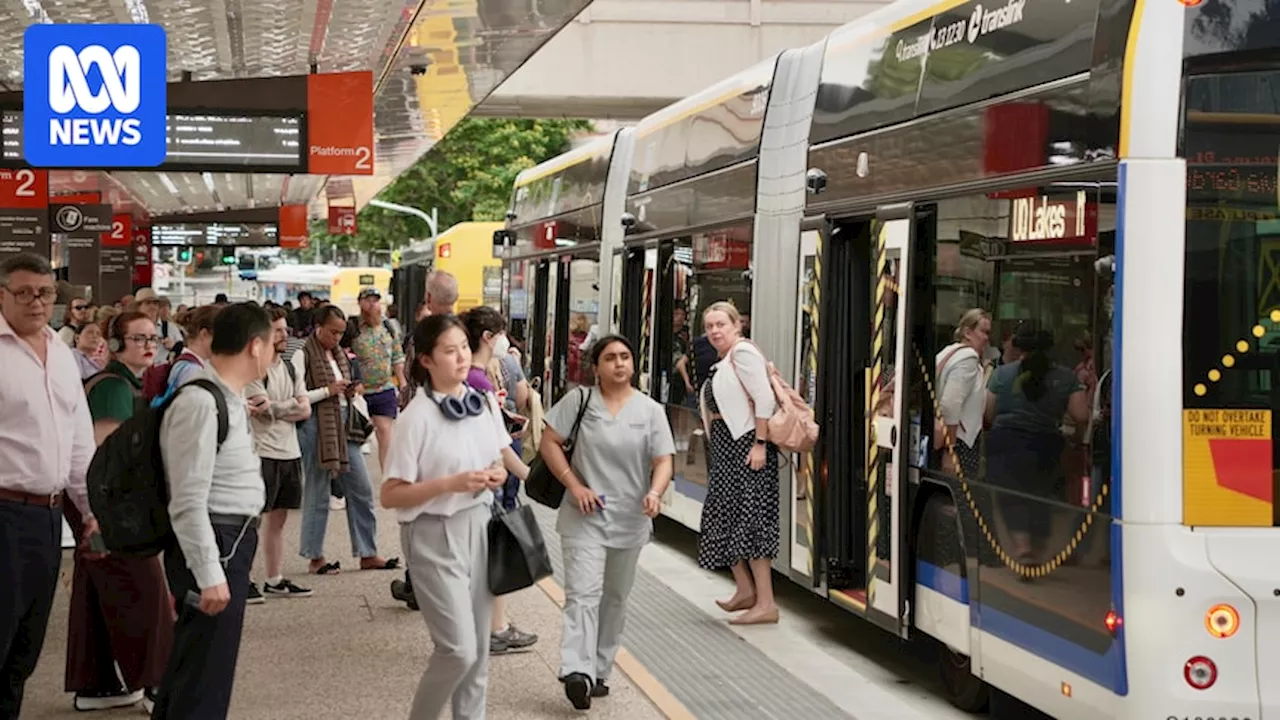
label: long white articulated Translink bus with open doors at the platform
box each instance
[495,0,1280,720]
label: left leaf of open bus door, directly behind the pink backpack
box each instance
[790,231,820,579]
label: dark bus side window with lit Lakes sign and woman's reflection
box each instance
[914,183,1115,565]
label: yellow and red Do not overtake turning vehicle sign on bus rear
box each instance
[1183,409,1275,528]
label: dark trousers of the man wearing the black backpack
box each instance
[151,518,257,720]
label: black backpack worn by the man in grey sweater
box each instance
[86,378,229,557]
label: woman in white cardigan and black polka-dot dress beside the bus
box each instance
[698,302,778,625]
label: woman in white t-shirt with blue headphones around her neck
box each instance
[381,315,515,720]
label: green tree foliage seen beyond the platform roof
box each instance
[311,118,591,259]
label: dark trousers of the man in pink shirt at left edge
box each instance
[0,500,63,720]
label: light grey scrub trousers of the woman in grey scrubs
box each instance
[561,538,641,682]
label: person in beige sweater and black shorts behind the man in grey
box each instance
[244,307,311,603]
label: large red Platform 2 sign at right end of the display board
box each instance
[307,70,374,176]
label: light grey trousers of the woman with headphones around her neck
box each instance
[401,505,493,720]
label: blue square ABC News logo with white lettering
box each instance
[22,23,168,168]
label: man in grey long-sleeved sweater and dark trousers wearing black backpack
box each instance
[151,302,275,720]
